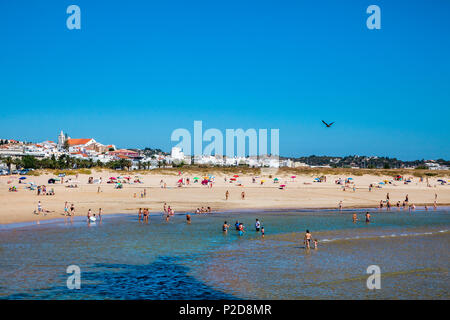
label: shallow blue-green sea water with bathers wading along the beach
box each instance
[0,209,450,299]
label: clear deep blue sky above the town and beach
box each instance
[0,0,450,160]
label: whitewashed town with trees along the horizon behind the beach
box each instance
[0,131,449,173]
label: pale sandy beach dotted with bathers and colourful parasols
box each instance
[0,171,450,224]
